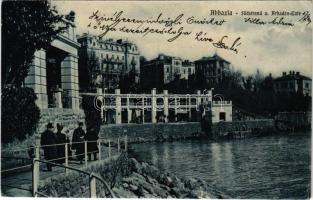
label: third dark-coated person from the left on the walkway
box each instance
[72,122,85,163]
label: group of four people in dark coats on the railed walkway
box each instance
[40,122,98,171]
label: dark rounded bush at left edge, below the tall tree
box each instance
[1,87,40,143]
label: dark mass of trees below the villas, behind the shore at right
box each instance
[163,70,311,115]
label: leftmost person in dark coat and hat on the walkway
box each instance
[40,123,57,171]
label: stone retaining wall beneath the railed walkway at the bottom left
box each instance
[38,156,127,198]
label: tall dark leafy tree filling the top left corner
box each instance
[2,0,75,86]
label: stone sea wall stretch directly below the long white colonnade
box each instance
[99,122,201,142]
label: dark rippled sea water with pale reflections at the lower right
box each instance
[131,134,311,198]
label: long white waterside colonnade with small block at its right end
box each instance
[94,88,232,124]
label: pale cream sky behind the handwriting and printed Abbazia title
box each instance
[52,0,312,77]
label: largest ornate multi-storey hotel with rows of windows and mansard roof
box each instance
[78,34,140,89]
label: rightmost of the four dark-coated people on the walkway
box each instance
[85,127,98,160]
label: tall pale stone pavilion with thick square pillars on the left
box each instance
[24,21,80,109]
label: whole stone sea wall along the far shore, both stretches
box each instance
[99,119,274,142]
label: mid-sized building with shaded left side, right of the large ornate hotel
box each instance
[140,54,195,88]
